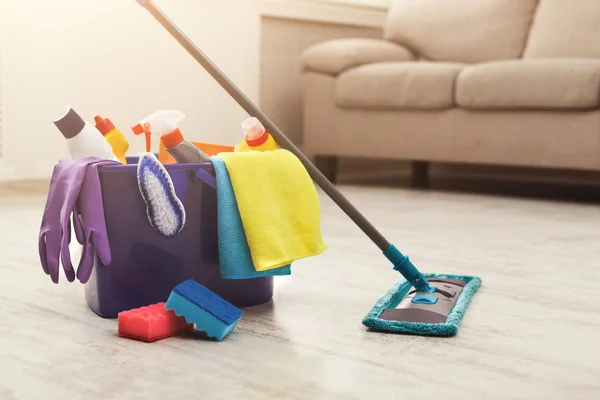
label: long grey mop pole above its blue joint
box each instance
[136,0,390,252]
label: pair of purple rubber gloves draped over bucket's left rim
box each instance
[38,158,119,283]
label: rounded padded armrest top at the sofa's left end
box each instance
[301,38,415,76]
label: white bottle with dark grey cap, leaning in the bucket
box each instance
[52,106,119,161]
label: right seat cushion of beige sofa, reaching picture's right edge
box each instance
[456,59,600,110]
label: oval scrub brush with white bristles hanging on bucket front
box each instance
[137,153,185,238]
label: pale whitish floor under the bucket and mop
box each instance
[0,182,600,400]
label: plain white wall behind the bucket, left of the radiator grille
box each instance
[0,0,260,179]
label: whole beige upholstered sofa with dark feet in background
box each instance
[302,0,600,185]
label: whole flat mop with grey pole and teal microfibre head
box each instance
[136,0,481,336]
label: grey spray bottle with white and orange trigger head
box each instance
[132,110,210,163]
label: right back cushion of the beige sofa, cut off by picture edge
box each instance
[523,0,600,58]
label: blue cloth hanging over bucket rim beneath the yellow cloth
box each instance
[211,156,292,279]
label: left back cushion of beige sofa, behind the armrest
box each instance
[385,0,537,63]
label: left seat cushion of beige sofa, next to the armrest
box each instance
[335,62,463,110]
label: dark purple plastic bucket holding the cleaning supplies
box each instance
[85,158,273,318]
